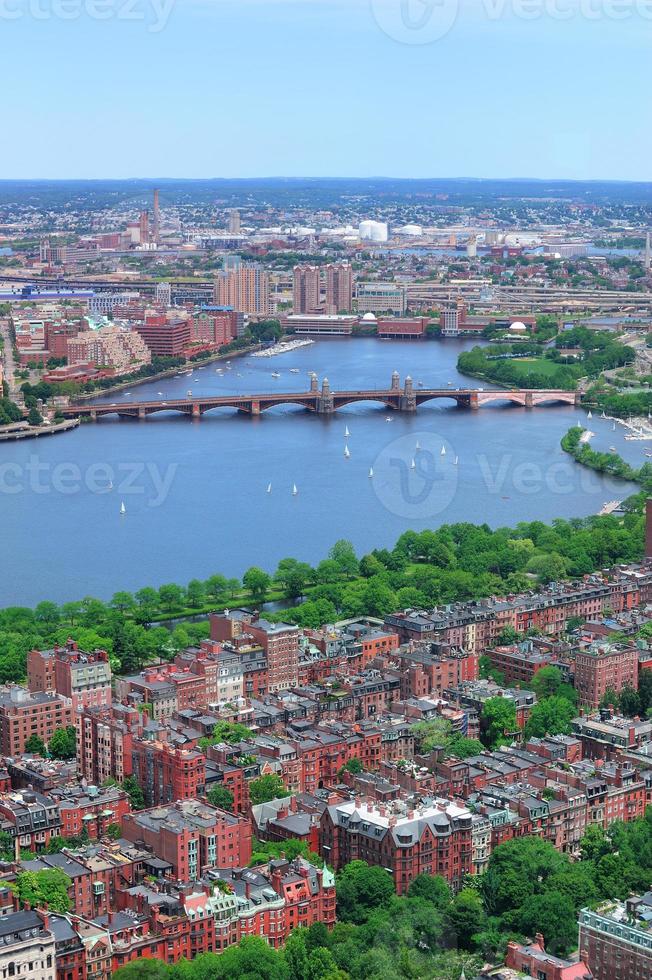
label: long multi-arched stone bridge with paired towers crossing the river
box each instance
[60,372,580,422]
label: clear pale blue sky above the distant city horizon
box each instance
[5,0,652,180]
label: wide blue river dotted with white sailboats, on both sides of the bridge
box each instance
[0,339,640,606]
